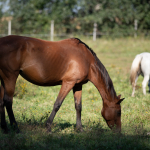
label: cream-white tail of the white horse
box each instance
[130,55,142,84]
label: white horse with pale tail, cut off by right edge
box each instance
[130,52,150,96]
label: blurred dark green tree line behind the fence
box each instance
[0,0,150,36]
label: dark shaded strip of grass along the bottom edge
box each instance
[0,123,150,150]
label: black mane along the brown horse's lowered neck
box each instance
[73,38,116,98]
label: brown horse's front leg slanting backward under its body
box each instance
[46,82,75,132]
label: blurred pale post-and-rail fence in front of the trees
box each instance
[0,18,150,41]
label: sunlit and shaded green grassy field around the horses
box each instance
[0,38,150,150]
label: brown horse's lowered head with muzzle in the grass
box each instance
[101,95,124,132]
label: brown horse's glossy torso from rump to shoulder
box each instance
[0,36,93,85]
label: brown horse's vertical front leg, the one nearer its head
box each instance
[73,85,83,131]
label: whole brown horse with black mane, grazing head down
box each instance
[0,35,123,133]
